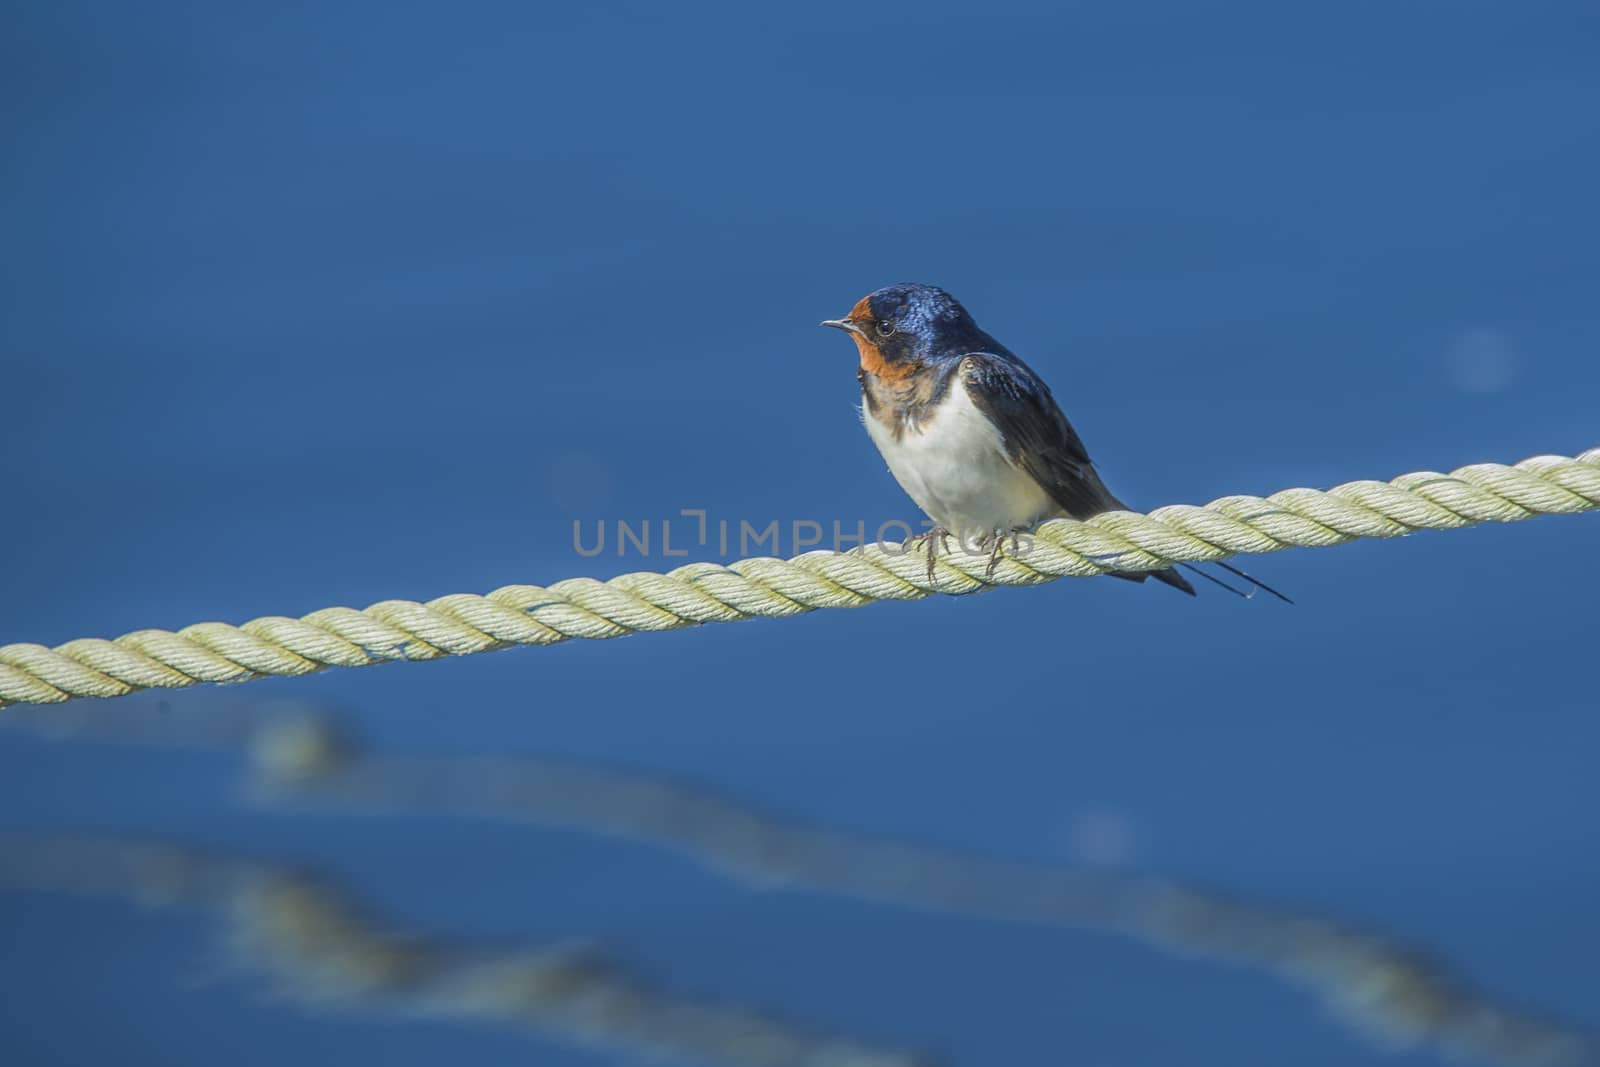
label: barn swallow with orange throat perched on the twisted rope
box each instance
[822,285,1288,600]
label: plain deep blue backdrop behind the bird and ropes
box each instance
[0,0,1600,1067]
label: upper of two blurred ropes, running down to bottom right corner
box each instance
[0,701,1600,1067]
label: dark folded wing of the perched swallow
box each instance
[958,352,1123,518]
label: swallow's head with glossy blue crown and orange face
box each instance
[822,283,992,381]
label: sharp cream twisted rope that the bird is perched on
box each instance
[0,448,1600,707]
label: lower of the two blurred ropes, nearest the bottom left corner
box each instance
[0,835,931,1067]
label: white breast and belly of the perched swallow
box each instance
[862,374,1059,537]
